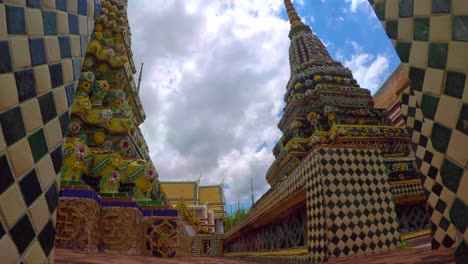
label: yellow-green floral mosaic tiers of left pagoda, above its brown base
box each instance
[62,1,165,202]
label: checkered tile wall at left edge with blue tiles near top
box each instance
[0,0,100,263]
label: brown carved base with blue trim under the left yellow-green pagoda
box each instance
[56,188,190,257]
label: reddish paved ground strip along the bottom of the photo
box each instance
[55,247,455,264]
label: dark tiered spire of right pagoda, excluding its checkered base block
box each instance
[266,0,430,238]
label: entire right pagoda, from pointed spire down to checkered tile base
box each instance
[225,0,428,262]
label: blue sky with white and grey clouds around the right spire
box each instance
[128,0,399,212]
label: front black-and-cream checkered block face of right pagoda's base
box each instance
[308,147,399,262]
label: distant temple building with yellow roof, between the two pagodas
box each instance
[160,180,226,233]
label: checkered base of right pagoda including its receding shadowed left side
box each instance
[225,145,400,262]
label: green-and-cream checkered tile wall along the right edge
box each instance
[370,0,468,258]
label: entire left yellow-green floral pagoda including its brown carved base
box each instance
[56,0,191,257]
